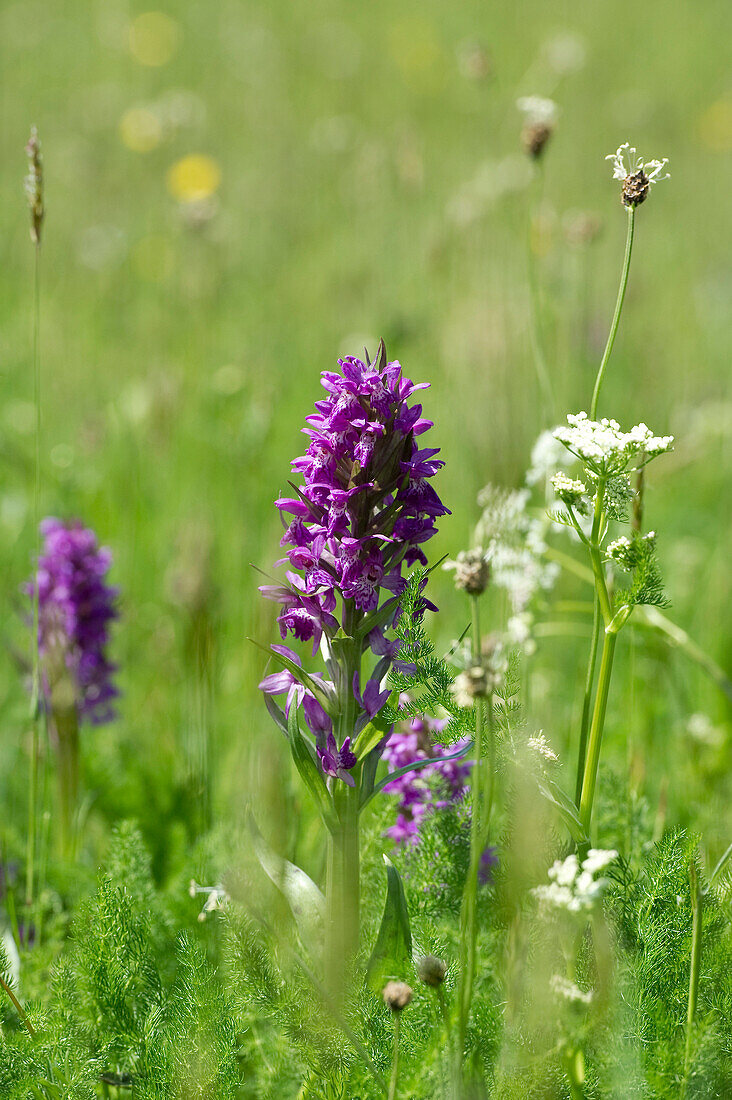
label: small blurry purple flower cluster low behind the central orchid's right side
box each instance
[383,717,473,844]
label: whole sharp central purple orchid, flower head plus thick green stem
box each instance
[260,341,448,991]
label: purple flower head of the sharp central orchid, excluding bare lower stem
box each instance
[260,341,448,784]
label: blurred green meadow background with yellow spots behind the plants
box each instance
[0,0,732,877]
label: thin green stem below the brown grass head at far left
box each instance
[25,237,41,905]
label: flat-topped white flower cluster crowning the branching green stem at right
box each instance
[554,413,674,477]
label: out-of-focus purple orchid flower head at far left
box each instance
[25,517,119,725]
